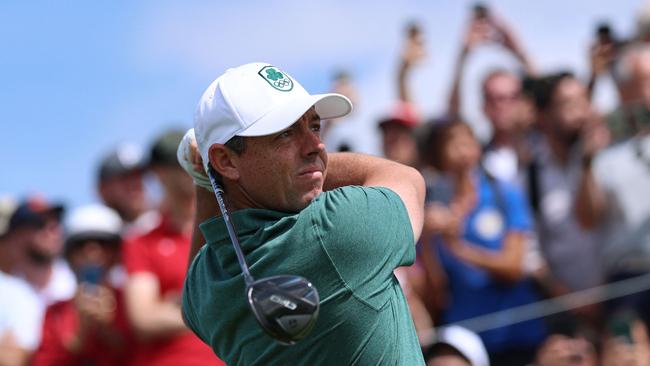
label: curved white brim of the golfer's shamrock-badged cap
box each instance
[236,93,352,136]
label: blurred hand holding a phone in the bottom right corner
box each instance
[602,321,650,366]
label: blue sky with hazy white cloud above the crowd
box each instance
[0,0,642,205]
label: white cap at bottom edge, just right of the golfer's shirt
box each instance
[434,325,490,366]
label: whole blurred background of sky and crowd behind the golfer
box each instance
[0,0,650,366]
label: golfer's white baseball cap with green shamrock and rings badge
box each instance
[194,62,352,166]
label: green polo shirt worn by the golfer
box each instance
[183,186,424,366]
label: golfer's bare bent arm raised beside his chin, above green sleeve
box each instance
[323,153,425,240]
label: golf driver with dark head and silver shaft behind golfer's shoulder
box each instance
[208,166,320,345]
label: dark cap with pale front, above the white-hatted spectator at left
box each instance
[97,144,146,181]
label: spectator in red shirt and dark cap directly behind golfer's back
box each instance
[124,131,223,366]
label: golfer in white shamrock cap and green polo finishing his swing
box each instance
[179,63,424,366]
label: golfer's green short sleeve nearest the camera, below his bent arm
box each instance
[311,186,415,308]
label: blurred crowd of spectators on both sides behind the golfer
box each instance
[0,6,650,366]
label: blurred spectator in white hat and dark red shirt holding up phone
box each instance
[32,205,133,366]
